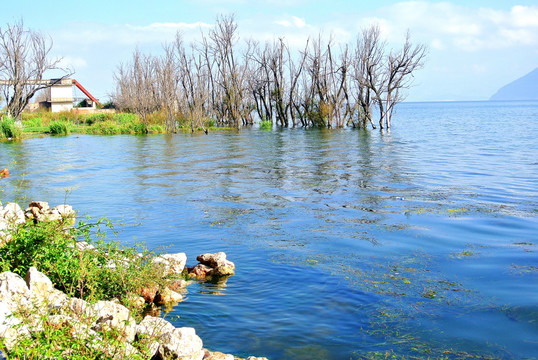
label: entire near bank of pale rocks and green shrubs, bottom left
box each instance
[0,201,267,360]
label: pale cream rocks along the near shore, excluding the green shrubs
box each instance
[0,202,267,360]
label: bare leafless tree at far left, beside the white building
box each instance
[0,20,73,120]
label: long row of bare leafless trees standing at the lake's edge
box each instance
[114,15,427,131]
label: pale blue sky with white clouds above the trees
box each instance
[0,0,538,101]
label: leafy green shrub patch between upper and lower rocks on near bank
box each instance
[0,219,170,304]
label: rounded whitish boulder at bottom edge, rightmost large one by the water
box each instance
[159,327,205,360]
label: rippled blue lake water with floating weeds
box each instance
[0,102,538,360]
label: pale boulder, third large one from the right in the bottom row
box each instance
[91,301,136,342]
